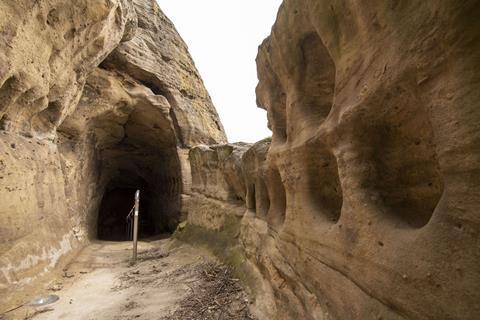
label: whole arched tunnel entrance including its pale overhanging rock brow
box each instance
[61,64,189,241]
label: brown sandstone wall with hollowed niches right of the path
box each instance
[184,0,480,320]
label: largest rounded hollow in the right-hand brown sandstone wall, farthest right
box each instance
[349,79,444,228]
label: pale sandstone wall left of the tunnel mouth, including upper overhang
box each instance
[0,1,136,309]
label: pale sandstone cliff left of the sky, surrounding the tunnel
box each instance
[0,0,226,312]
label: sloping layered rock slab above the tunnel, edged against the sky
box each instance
[102,0,226,147]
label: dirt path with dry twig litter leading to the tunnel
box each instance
[5,240,253,320]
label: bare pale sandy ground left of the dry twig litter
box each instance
[0,240,251,320]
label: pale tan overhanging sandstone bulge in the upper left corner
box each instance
[0,0,137,137]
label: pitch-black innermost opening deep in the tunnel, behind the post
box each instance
[97,187,155,241]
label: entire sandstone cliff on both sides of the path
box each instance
[0,0,480,320]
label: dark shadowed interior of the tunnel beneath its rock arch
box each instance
[91,100,183,241]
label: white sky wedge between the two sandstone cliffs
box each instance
[157,0,282,142]
